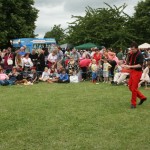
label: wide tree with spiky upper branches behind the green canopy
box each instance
[67,3,135,48]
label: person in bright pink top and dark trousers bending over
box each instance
[79,58,92,80]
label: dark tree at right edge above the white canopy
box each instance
[129,0,150,44]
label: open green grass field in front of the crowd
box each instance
[0,82,150,150]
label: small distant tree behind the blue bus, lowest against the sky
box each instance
[44,24,65,44]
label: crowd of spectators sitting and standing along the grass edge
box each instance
[0,46,150,87]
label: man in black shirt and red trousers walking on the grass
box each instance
[123,42,147,108]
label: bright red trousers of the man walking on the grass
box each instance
[129,70,145,106]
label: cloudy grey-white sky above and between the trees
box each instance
[34,0,140,38]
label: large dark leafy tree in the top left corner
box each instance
[0,0,38,46]
